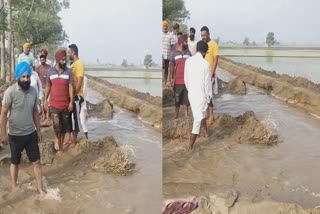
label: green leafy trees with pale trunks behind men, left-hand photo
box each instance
[0,0,70,82]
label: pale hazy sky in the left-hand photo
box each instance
[59,0,162,65]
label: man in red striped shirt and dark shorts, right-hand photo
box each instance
[170,36,191,118]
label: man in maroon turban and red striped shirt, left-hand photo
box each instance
[44,50,74,156]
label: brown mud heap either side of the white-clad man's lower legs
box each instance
[163,111,278,145]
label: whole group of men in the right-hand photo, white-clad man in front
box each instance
[162,21,219,150]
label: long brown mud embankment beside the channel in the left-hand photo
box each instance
[87,75,162,131]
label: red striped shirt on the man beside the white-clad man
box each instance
[171,50,191,85]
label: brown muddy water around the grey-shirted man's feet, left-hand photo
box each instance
[0,88,161,214]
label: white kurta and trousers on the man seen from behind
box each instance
[184,53,212,134]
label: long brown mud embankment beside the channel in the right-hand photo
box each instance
[219,57,320,117]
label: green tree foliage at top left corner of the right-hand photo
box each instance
[162,0,190,22]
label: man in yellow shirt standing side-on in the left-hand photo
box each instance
[68,44,84,148]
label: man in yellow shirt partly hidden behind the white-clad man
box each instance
[201,26,219,125]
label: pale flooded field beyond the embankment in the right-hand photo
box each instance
[221,49,320,83]
